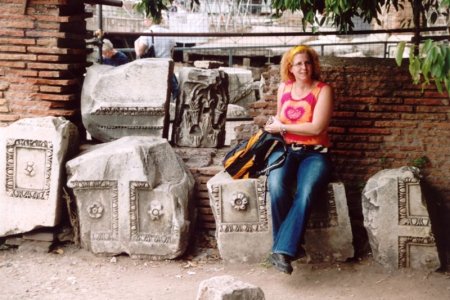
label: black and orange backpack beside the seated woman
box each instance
[222,129,286,179]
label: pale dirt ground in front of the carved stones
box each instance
[0,245,450,300]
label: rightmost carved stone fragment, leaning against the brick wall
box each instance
[362,167,439,270]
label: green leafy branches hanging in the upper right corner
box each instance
[272,0,450,94]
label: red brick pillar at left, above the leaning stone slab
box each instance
[0,0,89,126]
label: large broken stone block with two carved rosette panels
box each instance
[66,137,194,260]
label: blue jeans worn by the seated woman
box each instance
[268,148,331,257]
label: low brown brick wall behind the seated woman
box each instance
[251,57,450,258]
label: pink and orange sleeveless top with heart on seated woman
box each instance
[278,82,330,147]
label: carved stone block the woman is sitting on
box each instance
[207,171,353,262]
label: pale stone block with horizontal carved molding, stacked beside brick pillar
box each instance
[81,58,173,142]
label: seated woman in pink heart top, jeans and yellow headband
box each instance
[264,45,333,274]
